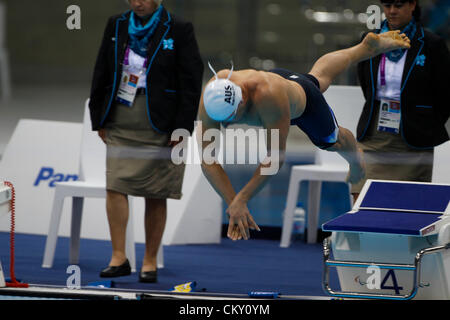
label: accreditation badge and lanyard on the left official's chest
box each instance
[117,48,147,107]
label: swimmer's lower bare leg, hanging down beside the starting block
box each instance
[326,127,366,184]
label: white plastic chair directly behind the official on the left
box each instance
[42,100,164,272]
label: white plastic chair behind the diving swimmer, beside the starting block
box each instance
[280,86,364,248]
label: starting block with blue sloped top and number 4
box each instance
[322,180,450,300]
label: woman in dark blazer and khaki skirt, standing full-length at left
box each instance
[89,0,203,282]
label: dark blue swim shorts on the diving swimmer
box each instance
[269,68,339,149]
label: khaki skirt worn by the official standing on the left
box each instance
[105,95,185,199]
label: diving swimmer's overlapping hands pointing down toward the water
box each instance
[226,197,261,240]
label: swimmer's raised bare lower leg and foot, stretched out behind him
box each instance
[309,30,411,93]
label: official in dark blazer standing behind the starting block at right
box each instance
[352,0,450,195]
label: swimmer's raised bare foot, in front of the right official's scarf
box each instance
[362,30,411,56]
